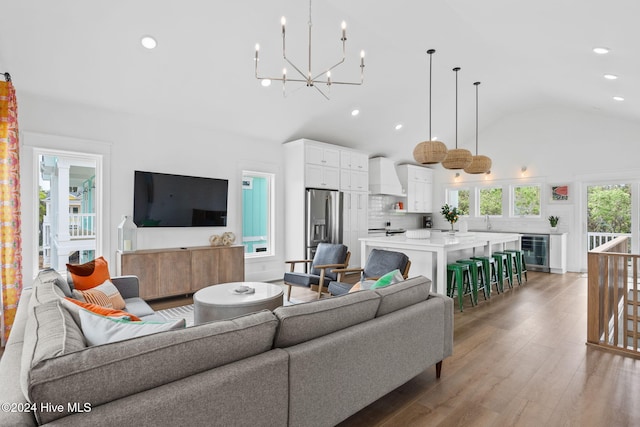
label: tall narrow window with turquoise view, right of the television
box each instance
[242,171,275,258]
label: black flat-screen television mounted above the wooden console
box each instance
[133,171,229,227]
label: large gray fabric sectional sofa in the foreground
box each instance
[0,273,453,426]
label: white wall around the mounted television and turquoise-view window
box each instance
[18,93,284,283]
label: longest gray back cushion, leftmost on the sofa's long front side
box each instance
[24,310,278,424]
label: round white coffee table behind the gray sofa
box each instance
[193,282,283,325]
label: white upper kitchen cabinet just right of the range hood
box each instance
[398,165,433,213]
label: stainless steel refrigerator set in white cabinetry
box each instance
[304,188,342,259]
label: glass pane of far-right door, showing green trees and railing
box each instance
[587,184,631,250]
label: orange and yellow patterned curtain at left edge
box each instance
[0,74,22,346]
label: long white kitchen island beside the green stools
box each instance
[360,231,521,295]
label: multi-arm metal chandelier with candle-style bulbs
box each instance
[255,0,364,99]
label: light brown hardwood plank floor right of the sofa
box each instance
[340,272,640,427]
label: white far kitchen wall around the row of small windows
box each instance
[434,106,640,271]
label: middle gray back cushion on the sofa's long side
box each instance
[273,292,380,347]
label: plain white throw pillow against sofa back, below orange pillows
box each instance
[80,309,186,345]
